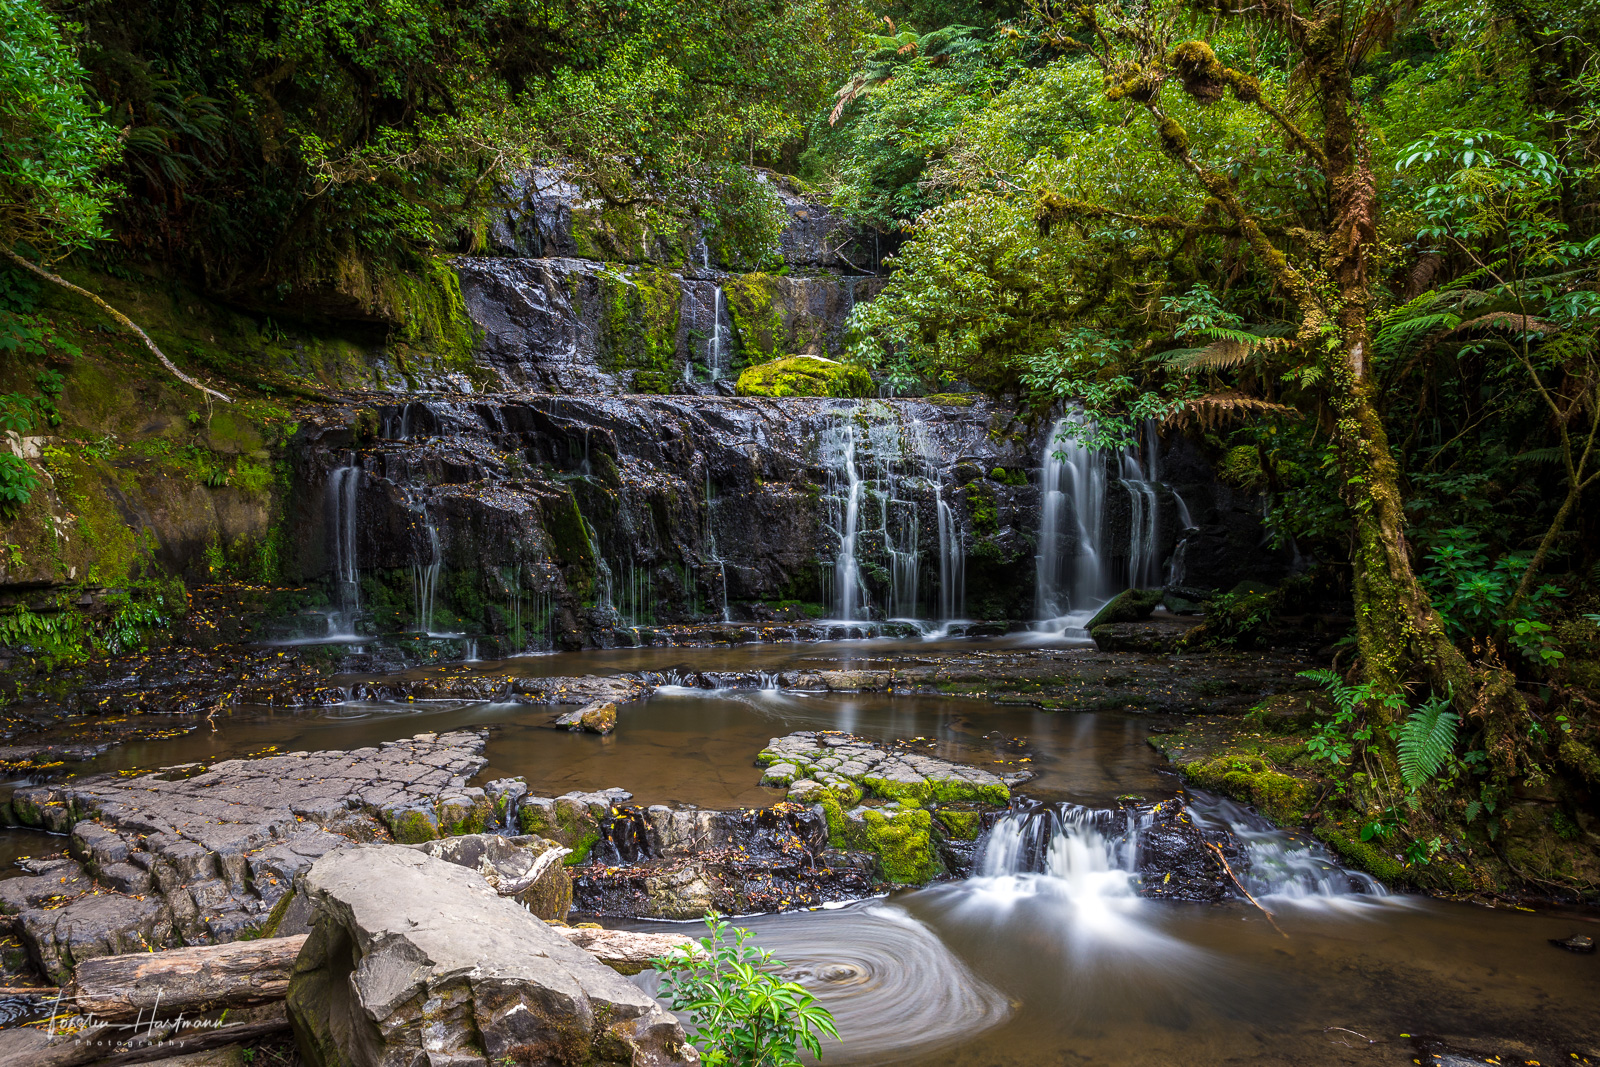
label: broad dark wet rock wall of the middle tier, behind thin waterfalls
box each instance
[291,395,1037,654]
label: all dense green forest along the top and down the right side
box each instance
[0,0,1600,888]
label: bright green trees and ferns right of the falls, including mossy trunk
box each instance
[814,0,1600,885]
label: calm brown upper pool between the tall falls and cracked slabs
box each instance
[43,686,1173,808]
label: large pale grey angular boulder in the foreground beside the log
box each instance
[288,846,698,1067]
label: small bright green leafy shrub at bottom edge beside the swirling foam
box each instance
[651,912,838,1067]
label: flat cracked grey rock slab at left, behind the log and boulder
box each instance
[0,733,493,982]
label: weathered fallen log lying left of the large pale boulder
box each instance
[62,934,306,1019]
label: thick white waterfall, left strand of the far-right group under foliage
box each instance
[1034,413,1109,621]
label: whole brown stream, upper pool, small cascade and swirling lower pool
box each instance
[0,641,1600,1067]
